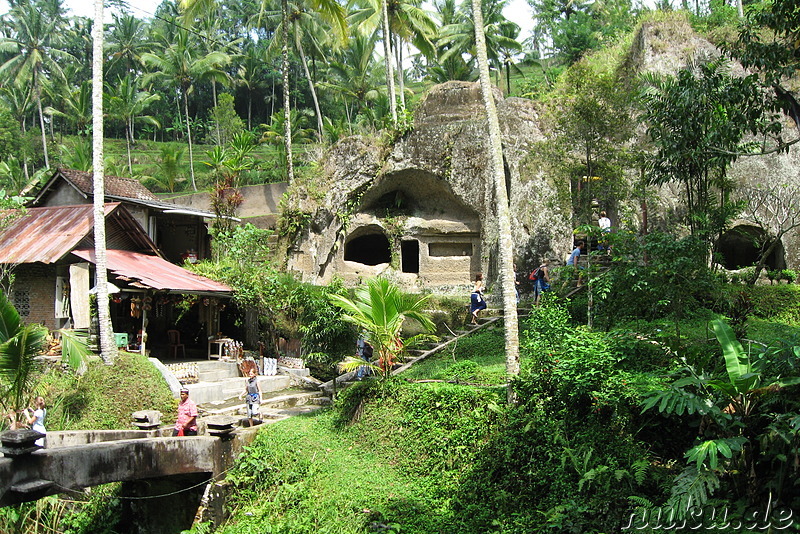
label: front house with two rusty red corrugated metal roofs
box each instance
[0,202,231,360]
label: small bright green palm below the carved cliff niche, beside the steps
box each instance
[328,277,435,380]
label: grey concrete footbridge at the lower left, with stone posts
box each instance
[0,426,258,533]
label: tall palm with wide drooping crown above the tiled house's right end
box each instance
[142,28,230,191]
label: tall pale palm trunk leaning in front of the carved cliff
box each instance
[472,0,519,404]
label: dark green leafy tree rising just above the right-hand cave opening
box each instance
[642,58,780,244]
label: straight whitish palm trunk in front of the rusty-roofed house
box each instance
[92,0,117,364]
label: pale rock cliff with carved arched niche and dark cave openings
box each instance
[289,82,572,291]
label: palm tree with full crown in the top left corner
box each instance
[0,2,75,167]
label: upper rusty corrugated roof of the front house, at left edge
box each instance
[0,203,128,264]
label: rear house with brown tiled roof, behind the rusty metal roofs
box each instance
[28,169,215,263]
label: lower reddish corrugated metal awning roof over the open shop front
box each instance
[73,249,232,293]
